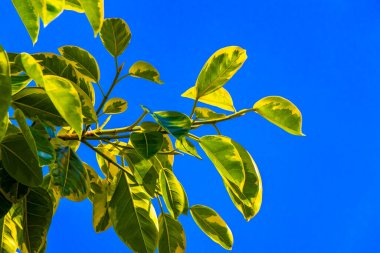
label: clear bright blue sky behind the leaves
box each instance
[0,0,380,253]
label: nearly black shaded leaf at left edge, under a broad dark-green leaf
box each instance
[0,166,29,204]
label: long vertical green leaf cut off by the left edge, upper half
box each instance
[0,46,12,141]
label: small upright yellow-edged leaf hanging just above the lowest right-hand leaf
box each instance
[160,169,186,219]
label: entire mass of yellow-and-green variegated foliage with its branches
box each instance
[0,0,303,253]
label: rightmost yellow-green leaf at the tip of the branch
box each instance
[253,96,304,136]
